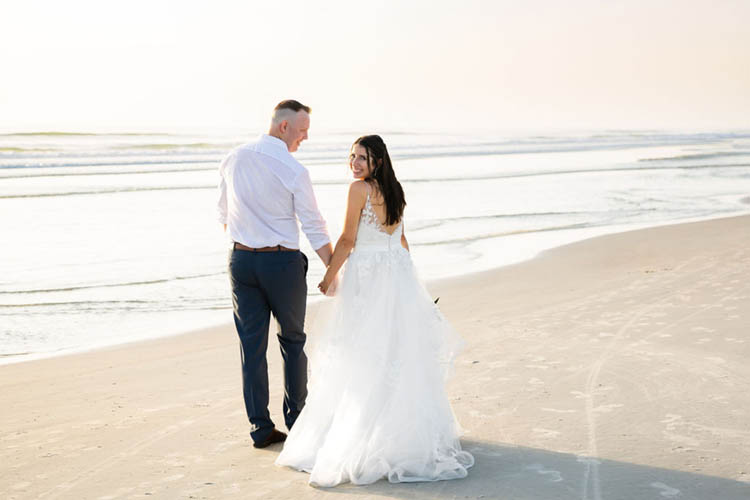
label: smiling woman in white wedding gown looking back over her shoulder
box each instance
[276,135,474,487]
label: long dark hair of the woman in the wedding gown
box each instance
[352,135,406,226]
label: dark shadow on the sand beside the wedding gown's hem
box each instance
[321,440,750,500]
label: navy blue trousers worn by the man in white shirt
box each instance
[229,250,307,442]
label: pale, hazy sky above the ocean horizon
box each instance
[0,0,750,131]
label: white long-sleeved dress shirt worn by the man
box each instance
[218,134,331,250]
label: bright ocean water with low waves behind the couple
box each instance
[0,130,750,363]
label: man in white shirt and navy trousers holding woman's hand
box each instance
[219,100,333,448]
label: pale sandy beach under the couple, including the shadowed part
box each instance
[0,216,750,500]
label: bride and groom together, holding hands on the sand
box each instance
[218,100,474,487]
